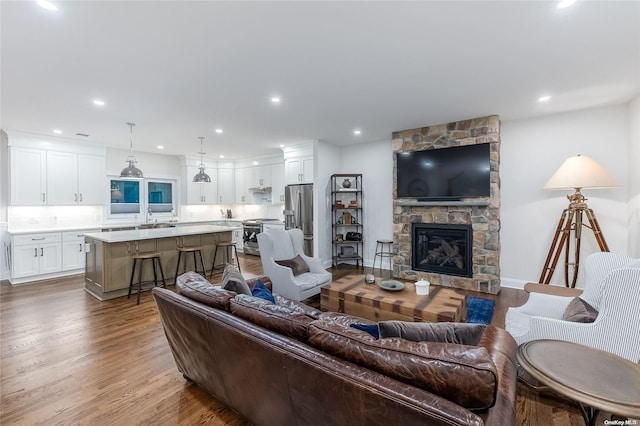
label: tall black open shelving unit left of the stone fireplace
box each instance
[331,173,363,268]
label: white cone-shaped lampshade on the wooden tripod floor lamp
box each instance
[543,155,620,189]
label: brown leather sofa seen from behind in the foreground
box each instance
[153,273,516,426]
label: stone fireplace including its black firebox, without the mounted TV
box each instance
[392,115,500,294]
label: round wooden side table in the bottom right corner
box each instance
[517,340,640,426]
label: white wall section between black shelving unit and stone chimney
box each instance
[338,139,393,268]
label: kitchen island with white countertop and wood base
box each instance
[85,225,234,300]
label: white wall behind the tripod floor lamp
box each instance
[500,105,630,287]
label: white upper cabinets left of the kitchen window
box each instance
[9,134,106,206]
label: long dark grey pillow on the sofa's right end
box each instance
[378,321,487,346]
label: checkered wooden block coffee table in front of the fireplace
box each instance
[320,275,466,322]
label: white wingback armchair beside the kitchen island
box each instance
[258,229,331,301]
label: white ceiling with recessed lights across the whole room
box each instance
[0,0,640,159]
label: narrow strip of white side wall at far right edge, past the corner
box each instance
[628,94,640,258]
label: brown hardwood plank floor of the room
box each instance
[0,255,603,426]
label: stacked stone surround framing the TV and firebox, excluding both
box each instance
[392,115,500,294]
